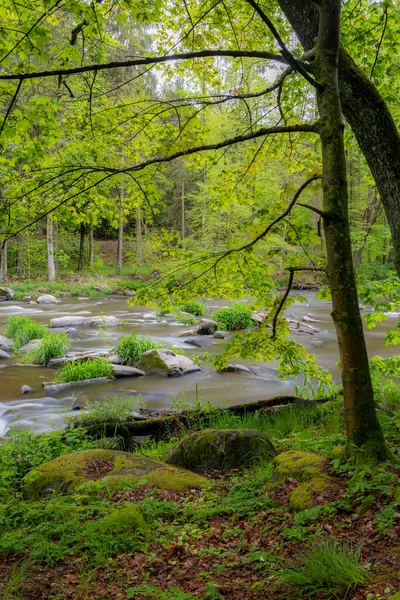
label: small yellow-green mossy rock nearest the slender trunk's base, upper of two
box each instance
[272,450,328,481]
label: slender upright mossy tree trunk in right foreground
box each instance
[316,0,390,461]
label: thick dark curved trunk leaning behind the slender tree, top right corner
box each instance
[278,0,400,275]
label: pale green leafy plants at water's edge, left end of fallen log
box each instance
[67,396,142,427]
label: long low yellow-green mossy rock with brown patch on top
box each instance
[22,448,208,499]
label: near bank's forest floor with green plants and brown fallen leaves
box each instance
[0,401,400,600]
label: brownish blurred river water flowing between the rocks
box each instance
[0,292,398,435]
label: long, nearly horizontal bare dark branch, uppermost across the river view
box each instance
[0,50,288,81]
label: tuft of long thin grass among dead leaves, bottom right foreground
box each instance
[280,542,368,599]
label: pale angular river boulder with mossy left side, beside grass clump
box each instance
[140,348,201,377]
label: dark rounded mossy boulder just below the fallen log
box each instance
[166,429,276,473]
